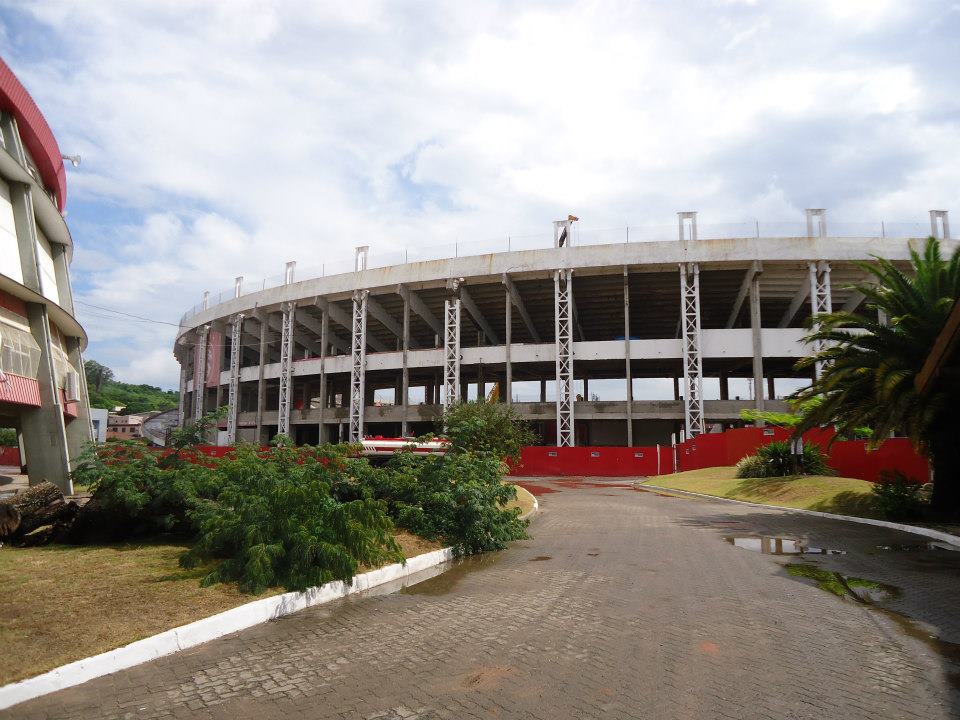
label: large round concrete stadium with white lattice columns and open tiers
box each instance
[174,209,953,446]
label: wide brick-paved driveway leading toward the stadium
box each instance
[5,481,960,720]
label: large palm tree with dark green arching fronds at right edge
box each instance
[794,237,960,514]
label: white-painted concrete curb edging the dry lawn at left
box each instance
[0,548,453,710]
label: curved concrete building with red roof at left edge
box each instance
[0,60,92,493]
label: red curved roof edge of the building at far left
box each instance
[0,58,67,212]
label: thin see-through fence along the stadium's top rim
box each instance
[180,220,931,327]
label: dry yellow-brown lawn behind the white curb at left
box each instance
[0,532,440,685]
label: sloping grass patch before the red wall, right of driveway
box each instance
[646,467,878,517]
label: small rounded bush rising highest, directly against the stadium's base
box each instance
[438,399,537,460]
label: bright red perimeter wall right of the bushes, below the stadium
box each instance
[510,427,929,482]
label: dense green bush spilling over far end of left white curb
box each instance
[339,452,526,555]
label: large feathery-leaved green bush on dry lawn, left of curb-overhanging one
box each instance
[181,445,403,593]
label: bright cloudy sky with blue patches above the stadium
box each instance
[0,0,960,387]
